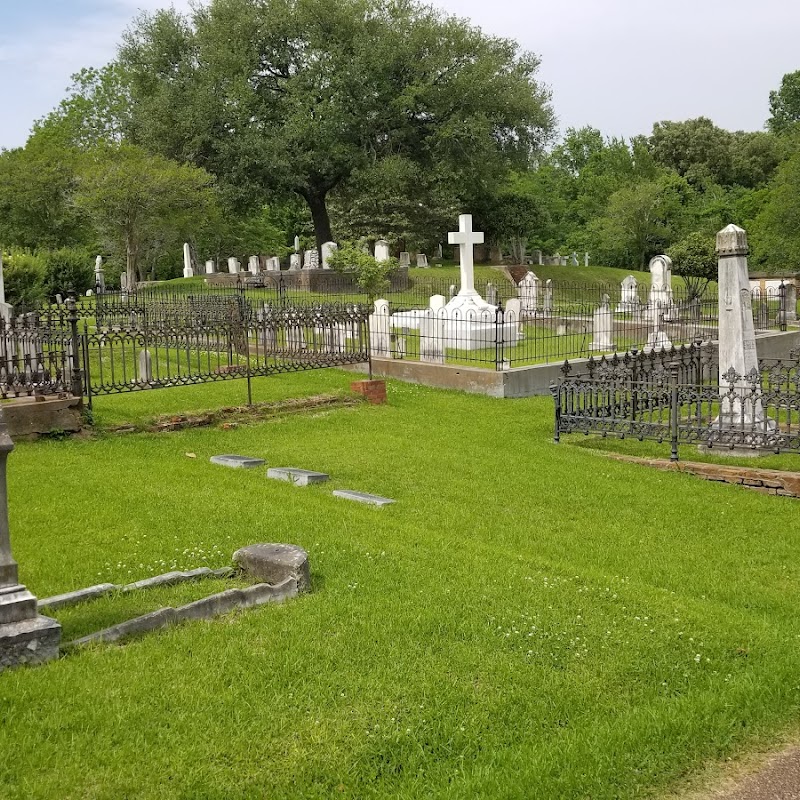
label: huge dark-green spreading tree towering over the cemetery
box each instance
[120,0,553,244]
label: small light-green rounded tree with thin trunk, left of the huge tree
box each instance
[74,144,216,285]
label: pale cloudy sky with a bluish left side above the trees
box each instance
[0,0,800,147]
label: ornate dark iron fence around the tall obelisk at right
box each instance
[551,348,800,461]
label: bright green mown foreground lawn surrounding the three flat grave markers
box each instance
[0,371,800,800]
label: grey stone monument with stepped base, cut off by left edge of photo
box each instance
[0,408,61,672]
